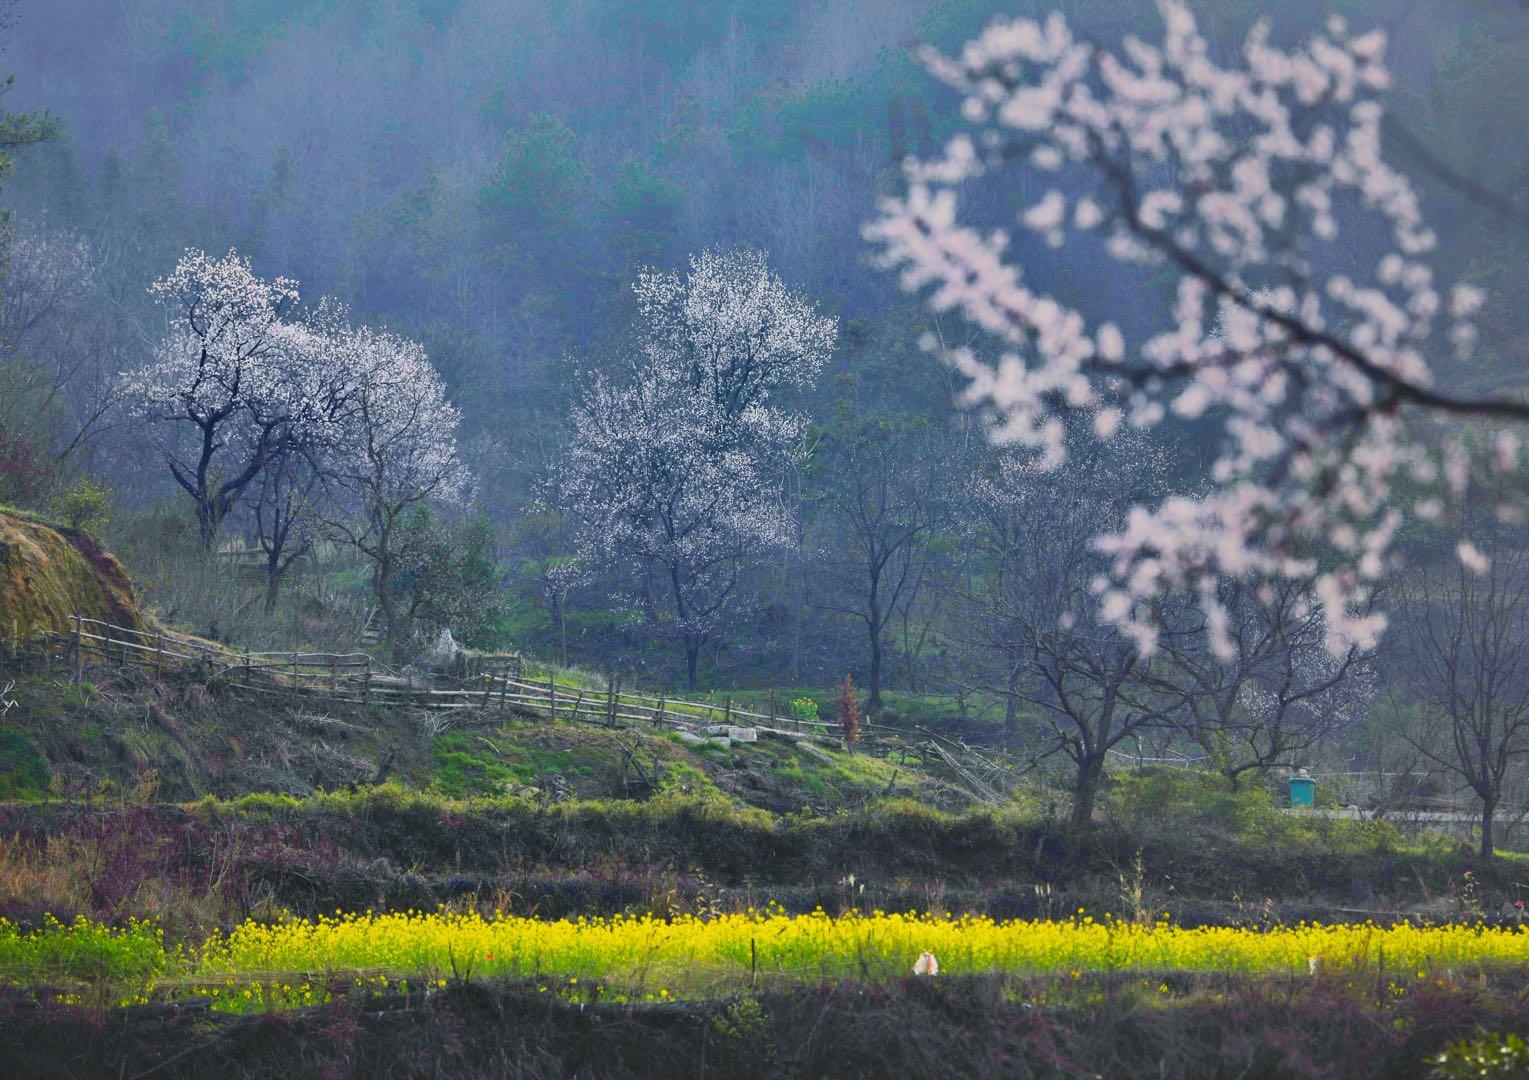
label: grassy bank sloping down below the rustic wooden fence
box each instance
[0,642,971,812]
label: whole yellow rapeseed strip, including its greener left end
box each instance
[0,910,1529,1010]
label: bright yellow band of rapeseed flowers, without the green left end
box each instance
[197,912,1529,978]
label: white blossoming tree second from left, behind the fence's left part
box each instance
[318,319,472,658]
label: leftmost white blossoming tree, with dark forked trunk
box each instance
[125,251,344,545]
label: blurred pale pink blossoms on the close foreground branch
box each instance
[865,0,1529,658]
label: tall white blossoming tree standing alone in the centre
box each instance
[547,251,836,688]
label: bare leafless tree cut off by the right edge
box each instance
[1399,529,1529,858]
